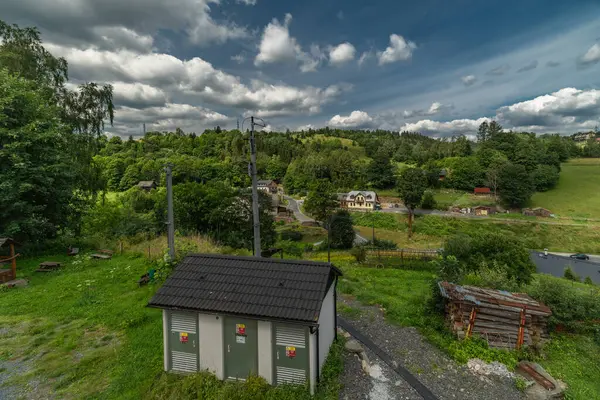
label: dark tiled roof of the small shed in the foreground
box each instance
[148,254,341,322]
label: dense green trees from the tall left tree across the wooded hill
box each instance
[0,21,582,247]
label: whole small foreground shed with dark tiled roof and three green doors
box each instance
[148,254,341,393]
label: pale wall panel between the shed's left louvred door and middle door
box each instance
[198,314,225,379]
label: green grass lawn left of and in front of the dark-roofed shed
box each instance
[0,252,343,400]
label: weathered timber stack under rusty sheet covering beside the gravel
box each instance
[438,282,552,349]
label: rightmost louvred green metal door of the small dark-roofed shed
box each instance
[273,324,310,385]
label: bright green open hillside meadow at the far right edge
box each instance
[532,158,600,219]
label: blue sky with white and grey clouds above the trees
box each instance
[0,0,600,136]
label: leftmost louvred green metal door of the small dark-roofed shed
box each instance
[168,312,200,372]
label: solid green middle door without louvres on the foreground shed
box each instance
[224,317,258,380]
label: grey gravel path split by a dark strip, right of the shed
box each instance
[338,296,524,400]
